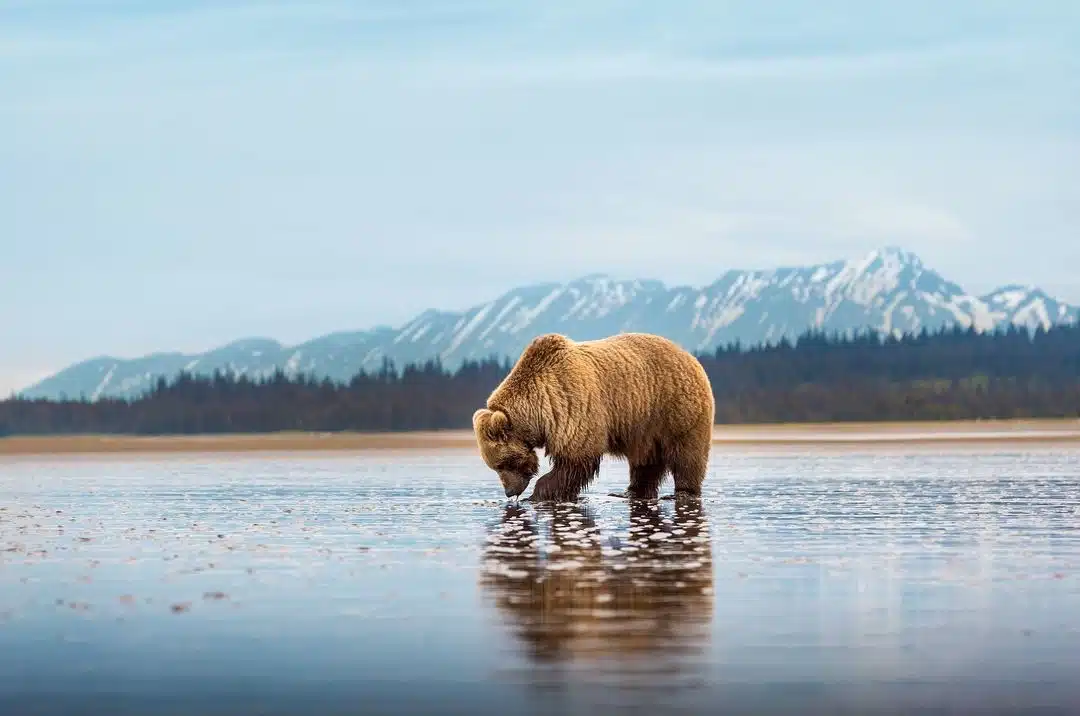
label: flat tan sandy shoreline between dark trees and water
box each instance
[6,419,1080,458]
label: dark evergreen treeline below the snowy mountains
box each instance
[0,326,1080,435]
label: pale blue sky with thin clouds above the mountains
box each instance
[0,0,1080,393]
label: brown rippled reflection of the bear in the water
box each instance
[482,500,713,686]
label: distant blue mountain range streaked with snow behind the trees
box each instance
[22,247,1080,400]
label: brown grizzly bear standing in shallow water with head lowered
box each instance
[473,333,716,501]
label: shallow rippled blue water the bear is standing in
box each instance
[0,448,1080,715]
